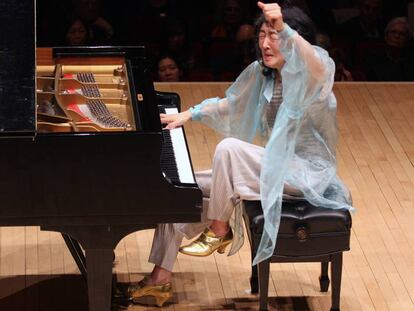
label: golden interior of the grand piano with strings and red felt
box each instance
[37,64,135,132]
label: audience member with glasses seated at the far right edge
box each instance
[365,17,414,81]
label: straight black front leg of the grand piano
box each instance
[85,249,113,311]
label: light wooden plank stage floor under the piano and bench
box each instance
[0,83,414,311]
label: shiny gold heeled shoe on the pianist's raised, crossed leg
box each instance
[180,228,233,257]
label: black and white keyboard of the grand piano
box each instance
[160,108,196,184]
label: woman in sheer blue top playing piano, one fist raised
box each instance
[129,2,352,306]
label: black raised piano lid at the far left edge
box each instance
[0,0,36,135]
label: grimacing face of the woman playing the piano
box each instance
[259,23,285,70]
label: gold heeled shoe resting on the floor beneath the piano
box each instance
[128,278,173,307]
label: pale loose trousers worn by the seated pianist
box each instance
[149,138,298,271]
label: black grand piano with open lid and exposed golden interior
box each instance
[0,0,201,311]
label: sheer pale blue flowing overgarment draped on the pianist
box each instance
[191,25,353,264]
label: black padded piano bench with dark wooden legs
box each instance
[243,201,352,311]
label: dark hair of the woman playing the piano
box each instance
[255,1,316,74]
